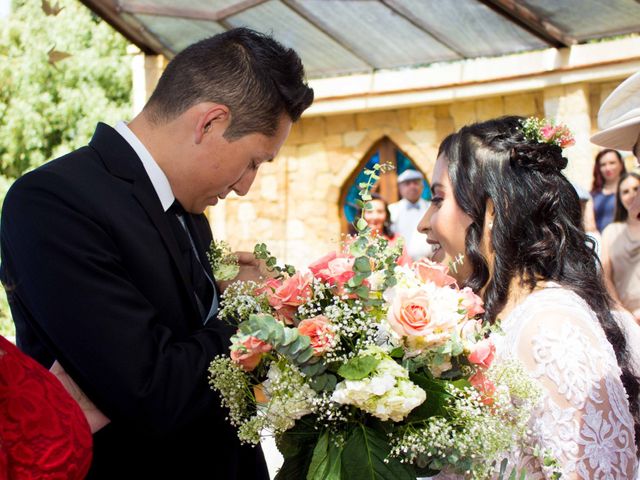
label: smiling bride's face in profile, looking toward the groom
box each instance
[418,155,471,282]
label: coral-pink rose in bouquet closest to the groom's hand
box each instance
[266,272,312,325]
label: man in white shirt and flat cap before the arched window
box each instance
[389,169,433,261]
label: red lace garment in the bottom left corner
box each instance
[0,336,92,480]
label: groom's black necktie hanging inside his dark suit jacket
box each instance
[167,200,214,323]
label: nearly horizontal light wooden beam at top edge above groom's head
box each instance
[119,0,267,22]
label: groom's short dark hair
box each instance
[145,28,313,140]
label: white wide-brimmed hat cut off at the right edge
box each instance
[591,72,640,150]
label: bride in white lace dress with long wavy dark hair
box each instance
[418,117,640,479]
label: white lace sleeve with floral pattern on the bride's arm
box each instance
[514,304,636,479]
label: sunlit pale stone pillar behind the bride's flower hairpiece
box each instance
[544,83,593,190]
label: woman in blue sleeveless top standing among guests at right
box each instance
[591,148,627,232]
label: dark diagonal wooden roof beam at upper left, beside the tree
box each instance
[80,0,173,58]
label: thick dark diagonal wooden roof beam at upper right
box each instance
[478,0,578,48]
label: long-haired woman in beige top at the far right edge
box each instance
[602,172,640,322]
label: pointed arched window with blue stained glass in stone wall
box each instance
[340,137,431,233]
